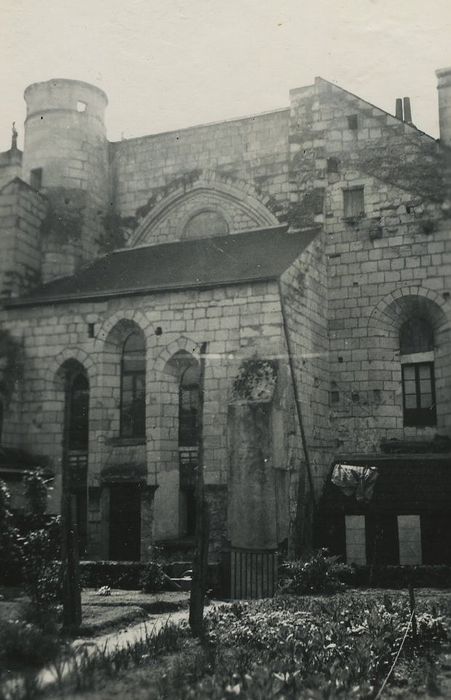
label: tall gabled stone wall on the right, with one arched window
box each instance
[290,79,451,460]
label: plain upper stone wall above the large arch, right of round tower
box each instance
[110,110,288,242]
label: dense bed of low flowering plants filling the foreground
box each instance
[0,591,450,700]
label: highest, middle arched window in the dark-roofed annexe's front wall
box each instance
[120,331,146,437]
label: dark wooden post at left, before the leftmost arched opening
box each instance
[61,378,81,633]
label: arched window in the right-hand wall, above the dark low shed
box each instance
[399,317,437,427]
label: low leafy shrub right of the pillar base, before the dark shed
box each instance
[280,549,353,595]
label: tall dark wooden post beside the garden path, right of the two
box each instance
[189,343,209,637]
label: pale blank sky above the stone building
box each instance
[0,0,451,150]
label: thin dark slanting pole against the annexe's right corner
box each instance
[278,280,316,556]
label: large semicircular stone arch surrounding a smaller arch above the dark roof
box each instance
[129,173,279,247]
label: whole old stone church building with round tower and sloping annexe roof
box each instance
[0,69,451,576]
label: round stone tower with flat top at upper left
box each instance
[22,79,109,280]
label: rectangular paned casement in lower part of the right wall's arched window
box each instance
[402,362,437,426]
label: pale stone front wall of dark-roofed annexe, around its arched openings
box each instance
[0,283,294,556]
